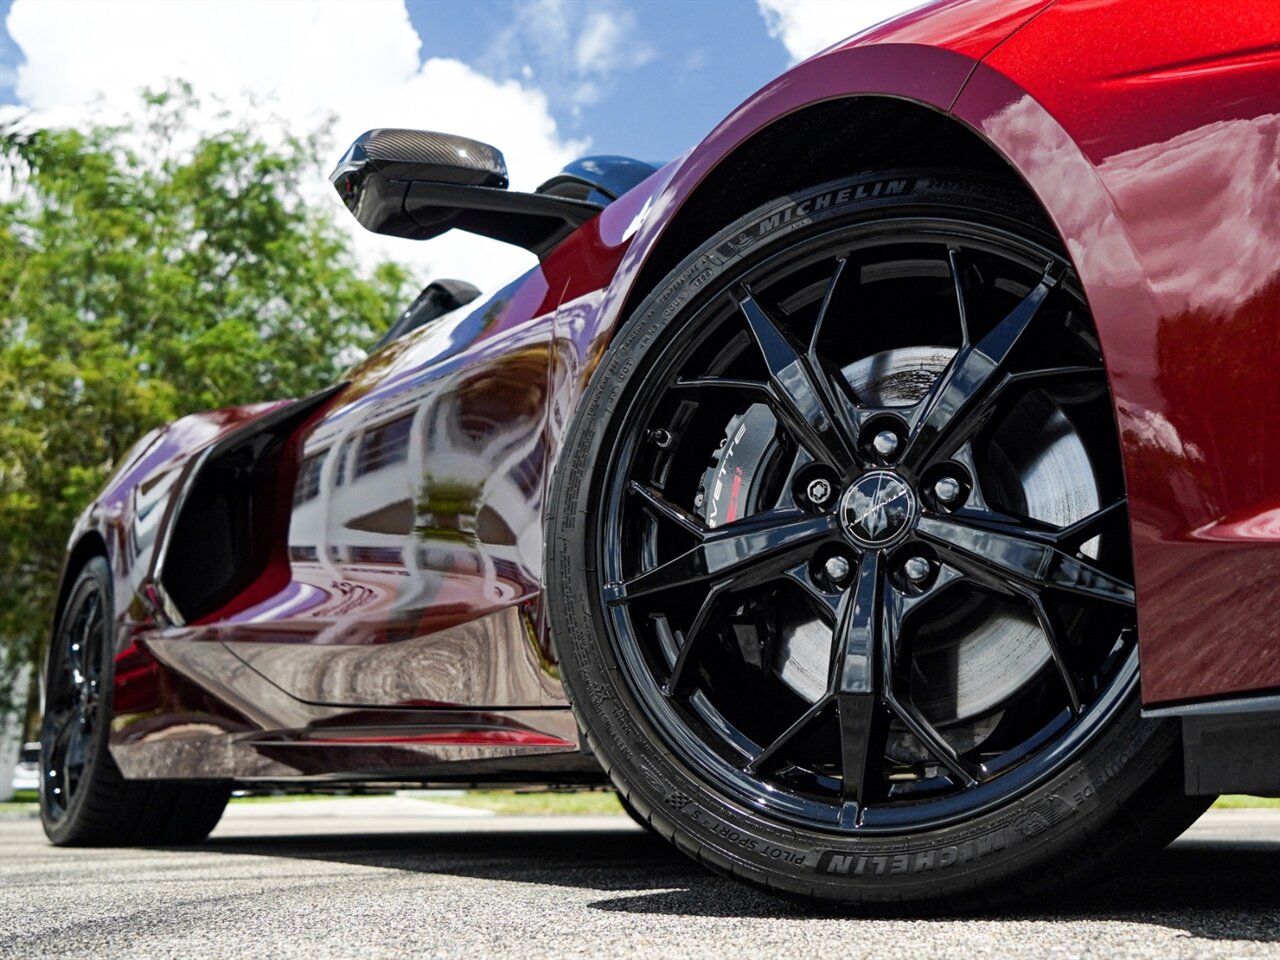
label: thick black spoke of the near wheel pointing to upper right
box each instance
[901,269,1059,468]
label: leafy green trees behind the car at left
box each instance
[0,87,408,710]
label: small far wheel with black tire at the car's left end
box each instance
[40,557,230,846]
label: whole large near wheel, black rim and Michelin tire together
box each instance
[547,172,1202,905]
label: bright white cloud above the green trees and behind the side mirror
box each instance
[6,0,589,288]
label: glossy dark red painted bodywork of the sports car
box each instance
[60,0,1280,780]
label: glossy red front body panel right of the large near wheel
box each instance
[955,0,1280,704]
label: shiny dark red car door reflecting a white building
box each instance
[224,269,563,707]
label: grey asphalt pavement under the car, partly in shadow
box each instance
[0,797,1280,960]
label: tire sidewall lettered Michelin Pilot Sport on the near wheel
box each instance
[545,172,1178,901]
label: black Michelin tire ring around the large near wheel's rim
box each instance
[545,172,1207,910]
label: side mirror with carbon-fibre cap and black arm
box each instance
[329,129,603,257]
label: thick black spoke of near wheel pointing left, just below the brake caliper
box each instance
[605,509,837,603]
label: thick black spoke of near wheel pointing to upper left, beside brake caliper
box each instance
[739,288,854,472]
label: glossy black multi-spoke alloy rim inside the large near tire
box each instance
[602,221,1135,829]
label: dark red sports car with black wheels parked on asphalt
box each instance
[41,0,1280,908]
